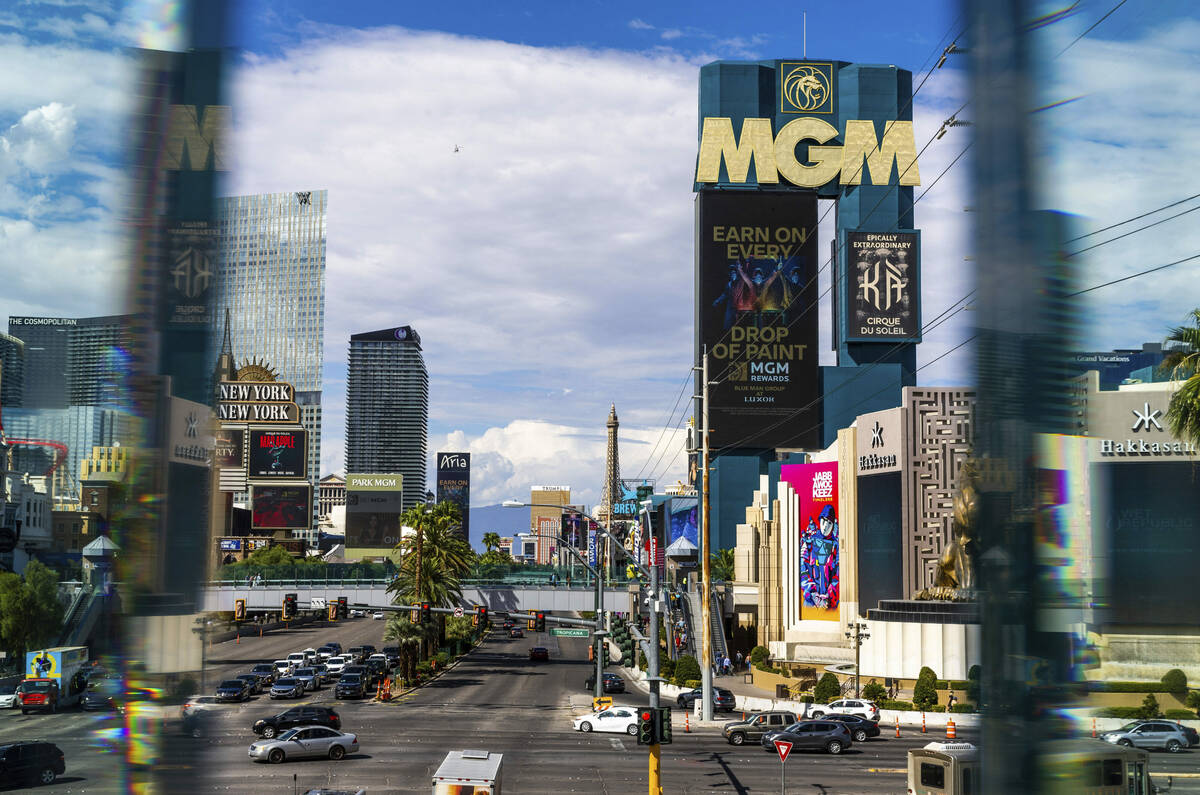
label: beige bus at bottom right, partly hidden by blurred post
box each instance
[908,740,1171,795]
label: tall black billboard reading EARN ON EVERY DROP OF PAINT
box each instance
[696,191,821,448]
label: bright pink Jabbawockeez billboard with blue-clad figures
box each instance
[780,461,841,621]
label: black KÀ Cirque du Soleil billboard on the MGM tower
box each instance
[842,232,920,342]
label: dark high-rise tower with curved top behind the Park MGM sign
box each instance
[346,325,430,510]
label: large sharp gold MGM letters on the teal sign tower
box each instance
[696,116,920,187]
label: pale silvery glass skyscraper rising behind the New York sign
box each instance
[216,191,329,533]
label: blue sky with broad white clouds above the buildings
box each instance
[0,0,1200,516]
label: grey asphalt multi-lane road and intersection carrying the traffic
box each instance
[0,618,1200,795]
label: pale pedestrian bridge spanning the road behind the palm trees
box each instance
[202,579,636,612]
